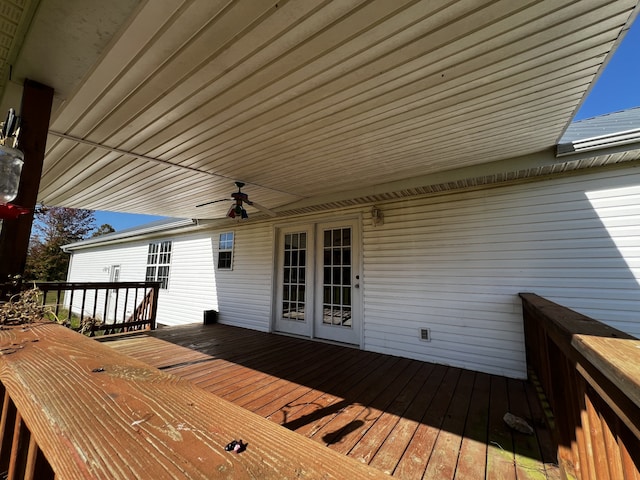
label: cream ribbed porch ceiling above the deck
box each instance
[0,0,638,218]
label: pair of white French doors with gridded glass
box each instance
[275,221,361,344]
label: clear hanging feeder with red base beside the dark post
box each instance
[0,108,29,219]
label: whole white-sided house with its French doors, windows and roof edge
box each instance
[65,108,640,377]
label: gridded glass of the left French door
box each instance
[282,232,307,322]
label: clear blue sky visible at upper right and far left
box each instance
[95,16,640,231]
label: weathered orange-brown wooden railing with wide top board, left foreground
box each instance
[0,323,389,480]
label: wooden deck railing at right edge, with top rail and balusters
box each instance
[520,293,640,480]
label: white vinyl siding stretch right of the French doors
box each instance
[364,170,640,377]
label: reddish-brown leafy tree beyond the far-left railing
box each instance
[24,206,95,281]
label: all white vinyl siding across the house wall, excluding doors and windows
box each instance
[65,168,640,378]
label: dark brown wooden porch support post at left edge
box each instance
[0,80,53,299]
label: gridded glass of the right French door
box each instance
[322,228,352,328]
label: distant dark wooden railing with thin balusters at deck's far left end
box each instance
[35,282,160,337]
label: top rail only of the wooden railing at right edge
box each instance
[520,293,640,408]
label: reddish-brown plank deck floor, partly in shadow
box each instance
[106,324,560,480]
